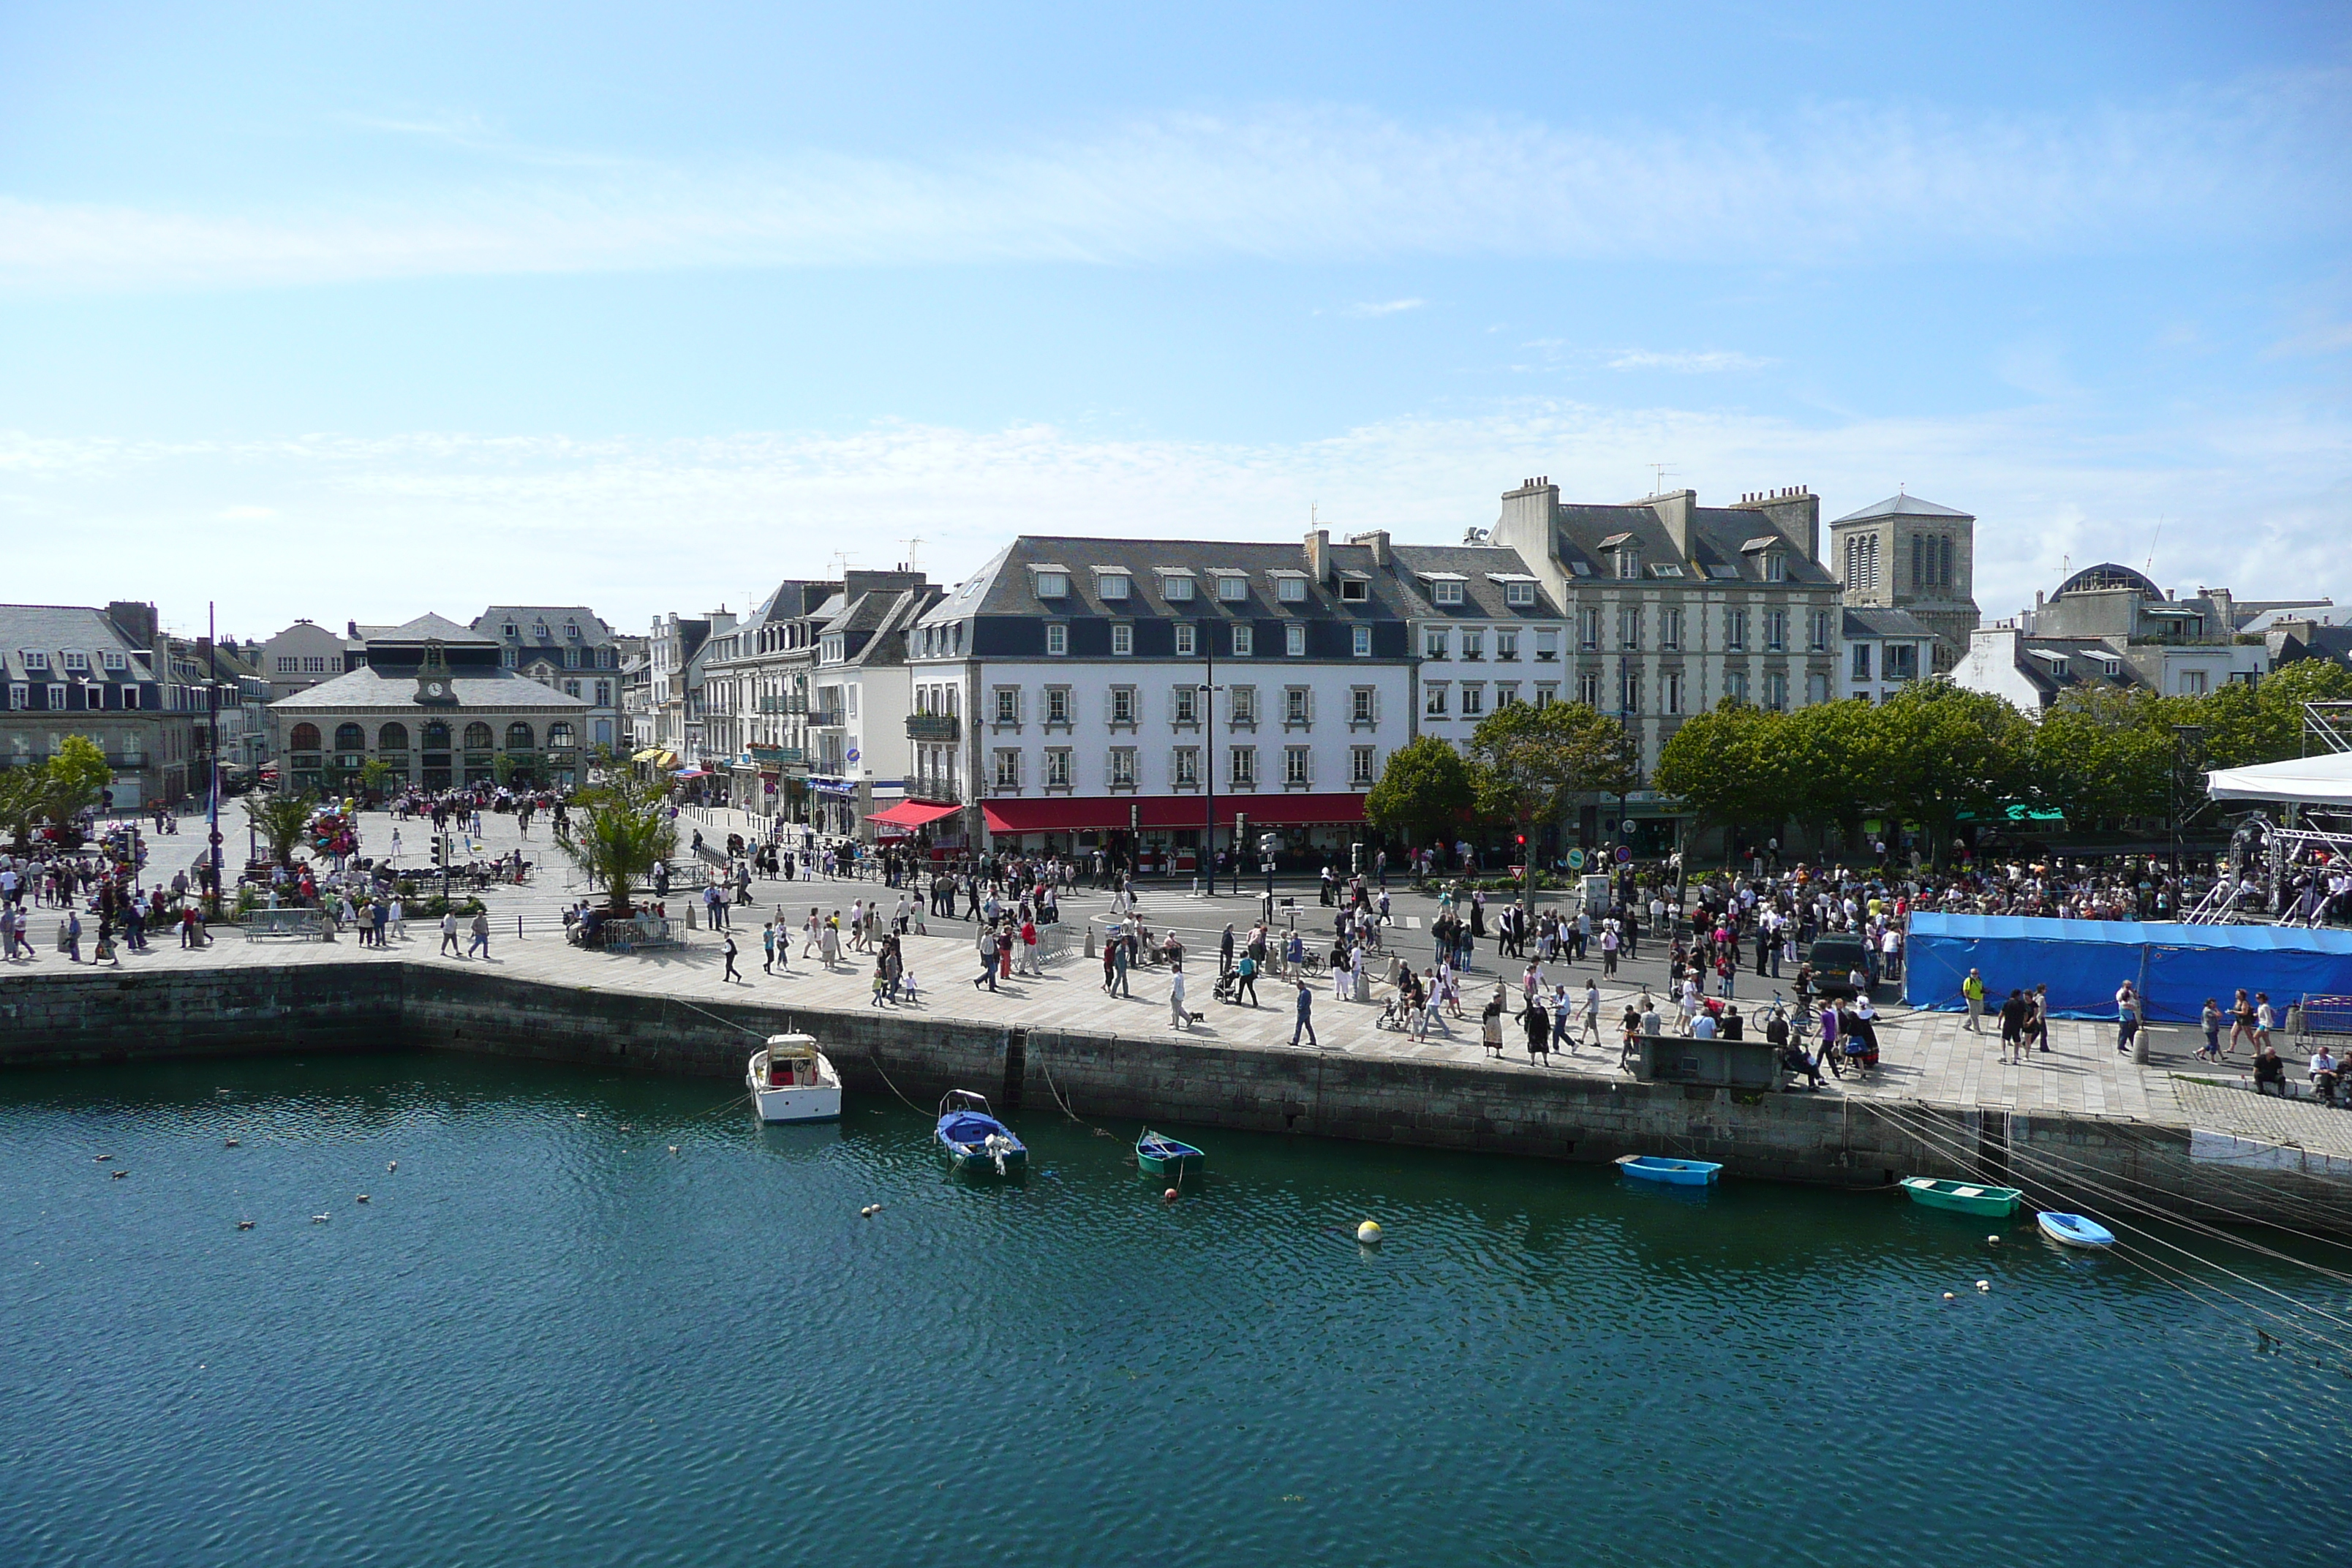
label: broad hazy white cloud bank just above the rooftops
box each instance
[0,399,2352,635]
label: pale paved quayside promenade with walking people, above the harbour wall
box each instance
[27,811,2352,1154]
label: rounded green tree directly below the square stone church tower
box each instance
[1863,679,2032,865]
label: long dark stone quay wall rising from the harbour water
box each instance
[0,964,2342,1227]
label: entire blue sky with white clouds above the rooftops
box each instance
[0,2,2352,635]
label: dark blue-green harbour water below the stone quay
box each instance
[0,1055,2352,1568]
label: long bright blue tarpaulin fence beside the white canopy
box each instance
[1903,914,2352,1022]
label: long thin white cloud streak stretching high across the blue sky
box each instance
[0,70,2352,287]
